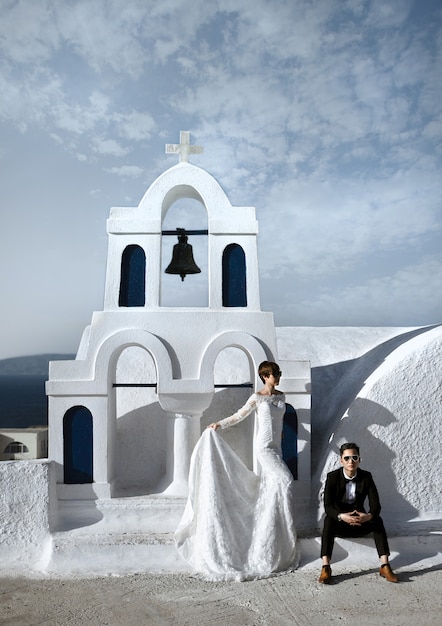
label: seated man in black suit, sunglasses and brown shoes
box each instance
[318,443,398,584]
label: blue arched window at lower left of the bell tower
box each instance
[63,406,93,484]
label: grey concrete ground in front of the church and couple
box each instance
[0,535,442,626]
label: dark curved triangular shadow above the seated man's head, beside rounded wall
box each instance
[312,324,438,475]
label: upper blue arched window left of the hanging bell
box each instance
[118,245,146,306]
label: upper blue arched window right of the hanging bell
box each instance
[222,243,247,307]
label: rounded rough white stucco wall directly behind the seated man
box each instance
[314,327,442,535]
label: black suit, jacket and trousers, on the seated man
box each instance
[321,467,390,558]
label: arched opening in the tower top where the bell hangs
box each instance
[160,197,209,307]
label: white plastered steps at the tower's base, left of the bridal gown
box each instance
[39,496,188,576]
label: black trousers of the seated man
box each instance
[321,515,390,559]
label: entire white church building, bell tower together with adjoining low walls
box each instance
[0,132,442,573]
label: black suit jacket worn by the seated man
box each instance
[324,467,381,521]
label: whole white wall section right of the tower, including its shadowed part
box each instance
[277,326,442,535]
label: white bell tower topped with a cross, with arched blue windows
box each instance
[47,132,306,499]
